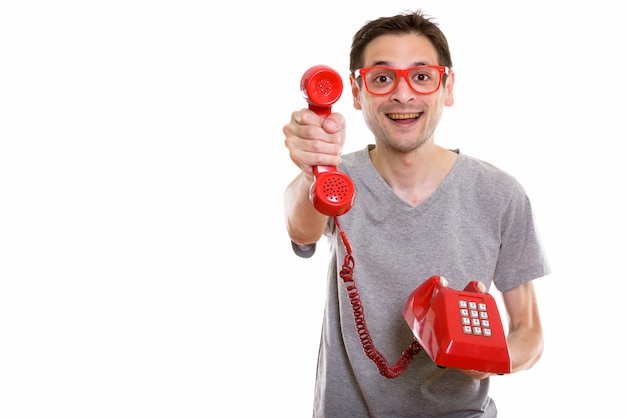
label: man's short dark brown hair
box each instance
[350,10,452,74]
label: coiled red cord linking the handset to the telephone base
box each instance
[334,216,422,379]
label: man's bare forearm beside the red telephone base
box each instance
[460,281,543,379]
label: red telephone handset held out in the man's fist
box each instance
[300,65,355,216]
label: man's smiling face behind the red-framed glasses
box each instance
[352,34,454,153]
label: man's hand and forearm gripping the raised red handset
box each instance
[283,109,345,244]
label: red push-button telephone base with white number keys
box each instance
[402,276,511,374]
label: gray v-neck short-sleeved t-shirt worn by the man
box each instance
[294,145,549,418]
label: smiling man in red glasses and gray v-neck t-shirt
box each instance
[283,11,549,417]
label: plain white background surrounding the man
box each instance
[0,0,626,418]
